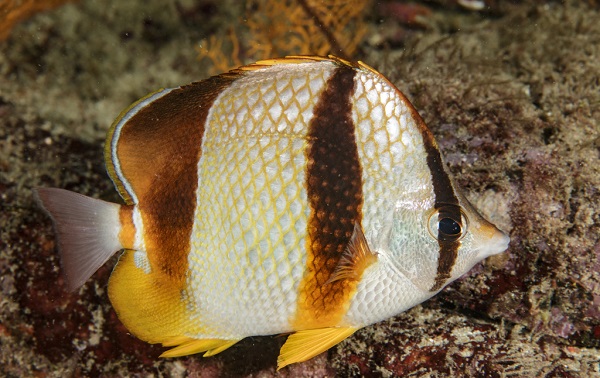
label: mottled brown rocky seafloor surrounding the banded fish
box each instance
[0,0,600,377]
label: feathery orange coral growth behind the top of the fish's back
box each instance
[197,0,370,72]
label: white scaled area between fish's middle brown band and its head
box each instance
[344,71,437,325]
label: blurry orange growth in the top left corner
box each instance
[0,0,74,41]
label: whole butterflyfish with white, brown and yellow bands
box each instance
[34,56,510,369]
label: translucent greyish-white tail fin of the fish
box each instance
[33,188,123,291]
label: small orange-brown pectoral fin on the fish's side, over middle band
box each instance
[325,222,377,285]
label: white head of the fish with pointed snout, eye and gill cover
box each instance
[379,188,510,295]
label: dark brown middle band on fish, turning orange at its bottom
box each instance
[296,67,363,328]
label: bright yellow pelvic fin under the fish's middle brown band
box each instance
[277,327,358,370]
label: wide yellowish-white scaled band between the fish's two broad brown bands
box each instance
[186,64,334,339]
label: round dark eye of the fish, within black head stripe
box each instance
[427,205,468,242]
